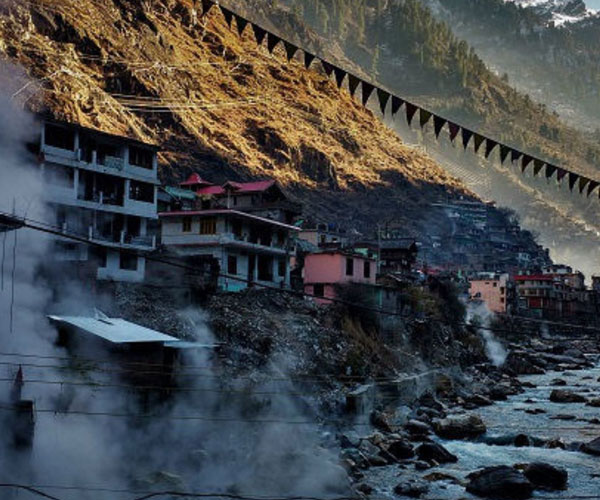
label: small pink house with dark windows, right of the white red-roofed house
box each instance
[304,250,377,304]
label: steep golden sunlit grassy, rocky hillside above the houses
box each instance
[0,0,476,236]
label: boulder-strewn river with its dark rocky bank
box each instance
[340,339,600,498]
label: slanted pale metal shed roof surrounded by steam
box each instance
[48,315,179,344]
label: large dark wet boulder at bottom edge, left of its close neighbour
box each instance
[466,465,534,499]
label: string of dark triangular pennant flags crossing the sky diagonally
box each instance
[201,0,600,201]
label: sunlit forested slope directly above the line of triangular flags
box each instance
[260,0,600,176]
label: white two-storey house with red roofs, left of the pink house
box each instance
[159,174,299,291]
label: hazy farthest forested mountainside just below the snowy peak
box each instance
[423,0,600,131]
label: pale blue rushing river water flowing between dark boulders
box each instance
[368,364,600,499]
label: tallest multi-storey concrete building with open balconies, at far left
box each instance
[40,120,159,282]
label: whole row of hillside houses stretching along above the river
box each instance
[31,120,600,317]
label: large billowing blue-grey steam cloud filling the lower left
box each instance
[0,61,348,500]
